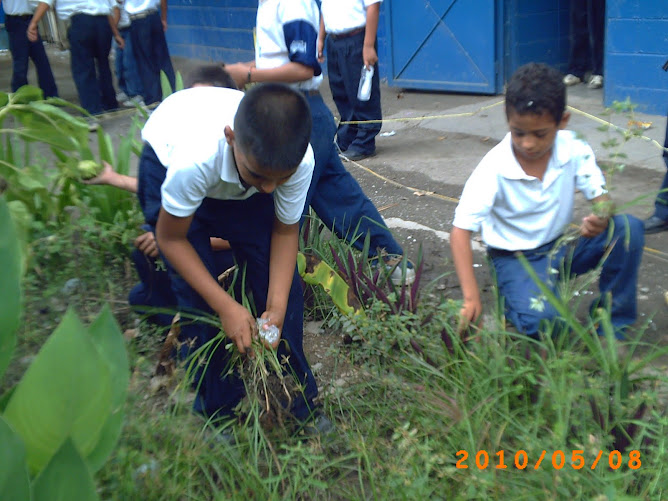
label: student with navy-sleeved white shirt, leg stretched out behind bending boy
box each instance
[225,0,415,284]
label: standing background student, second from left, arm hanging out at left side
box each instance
[27,0,118,115]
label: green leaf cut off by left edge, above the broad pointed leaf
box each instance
[0,196,22,378]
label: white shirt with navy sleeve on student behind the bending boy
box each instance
[255,0,322,90]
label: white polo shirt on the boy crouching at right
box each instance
[453,131,607,251]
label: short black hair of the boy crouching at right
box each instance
[506,63,566,124]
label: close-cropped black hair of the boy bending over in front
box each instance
[234,83,311,172]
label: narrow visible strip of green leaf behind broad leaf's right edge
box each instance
[86,305,130,471]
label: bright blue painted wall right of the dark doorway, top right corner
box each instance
[603,0,668,115]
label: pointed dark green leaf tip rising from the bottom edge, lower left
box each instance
[33,437,100,501]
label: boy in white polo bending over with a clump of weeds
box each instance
[137,84,332,431]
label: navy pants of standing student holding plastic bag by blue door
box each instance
[327,30,383,155]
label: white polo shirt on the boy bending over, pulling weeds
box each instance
[142,87,315,224]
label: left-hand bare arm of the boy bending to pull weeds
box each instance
[156,208,258,353]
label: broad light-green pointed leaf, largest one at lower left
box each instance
[5,310,112,474]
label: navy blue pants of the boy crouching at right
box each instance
[488,214,645,339]
